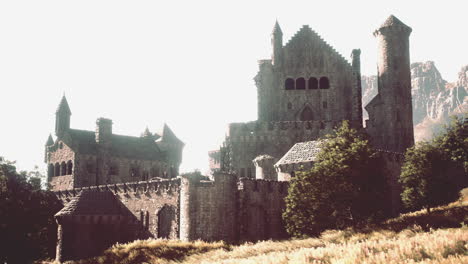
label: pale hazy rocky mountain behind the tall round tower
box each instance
[362,61,468,141]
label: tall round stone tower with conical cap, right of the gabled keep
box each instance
[366,15,414,153]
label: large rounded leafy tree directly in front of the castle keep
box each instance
[283,121,382,236]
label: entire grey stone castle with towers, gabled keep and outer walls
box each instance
[45,16,414,261]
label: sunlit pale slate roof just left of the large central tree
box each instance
[275,140,323,166]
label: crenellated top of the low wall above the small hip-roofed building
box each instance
[54,178,180,200]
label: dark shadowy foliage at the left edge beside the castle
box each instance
[0,158,61,264]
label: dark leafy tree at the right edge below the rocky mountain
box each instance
[400,118,468,210]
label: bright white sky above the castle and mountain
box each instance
[0,0,468,174]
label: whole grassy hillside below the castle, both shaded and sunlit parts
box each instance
[49,196,468,264]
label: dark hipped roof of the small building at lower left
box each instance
[55,190,128,217]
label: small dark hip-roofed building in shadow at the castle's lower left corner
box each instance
[55,190,151,262]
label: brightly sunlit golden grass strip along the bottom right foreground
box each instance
[177,228,468,264]
